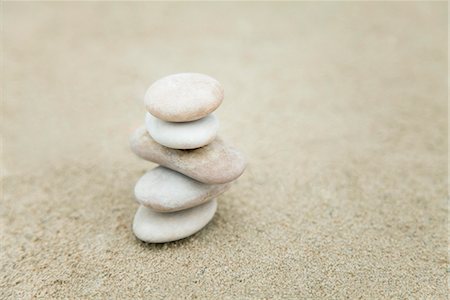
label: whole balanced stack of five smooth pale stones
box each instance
[130,73,245,243]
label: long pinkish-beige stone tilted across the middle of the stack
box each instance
[130,127,245,184]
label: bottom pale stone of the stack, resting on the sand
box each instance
[133,199,217,243]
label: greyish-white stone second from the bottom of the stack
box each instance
[134,166,230,212]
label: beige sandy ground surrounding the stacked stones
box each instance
[0,2,448,299]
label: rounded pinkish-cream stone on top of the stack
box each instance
[144,73,223,122]
